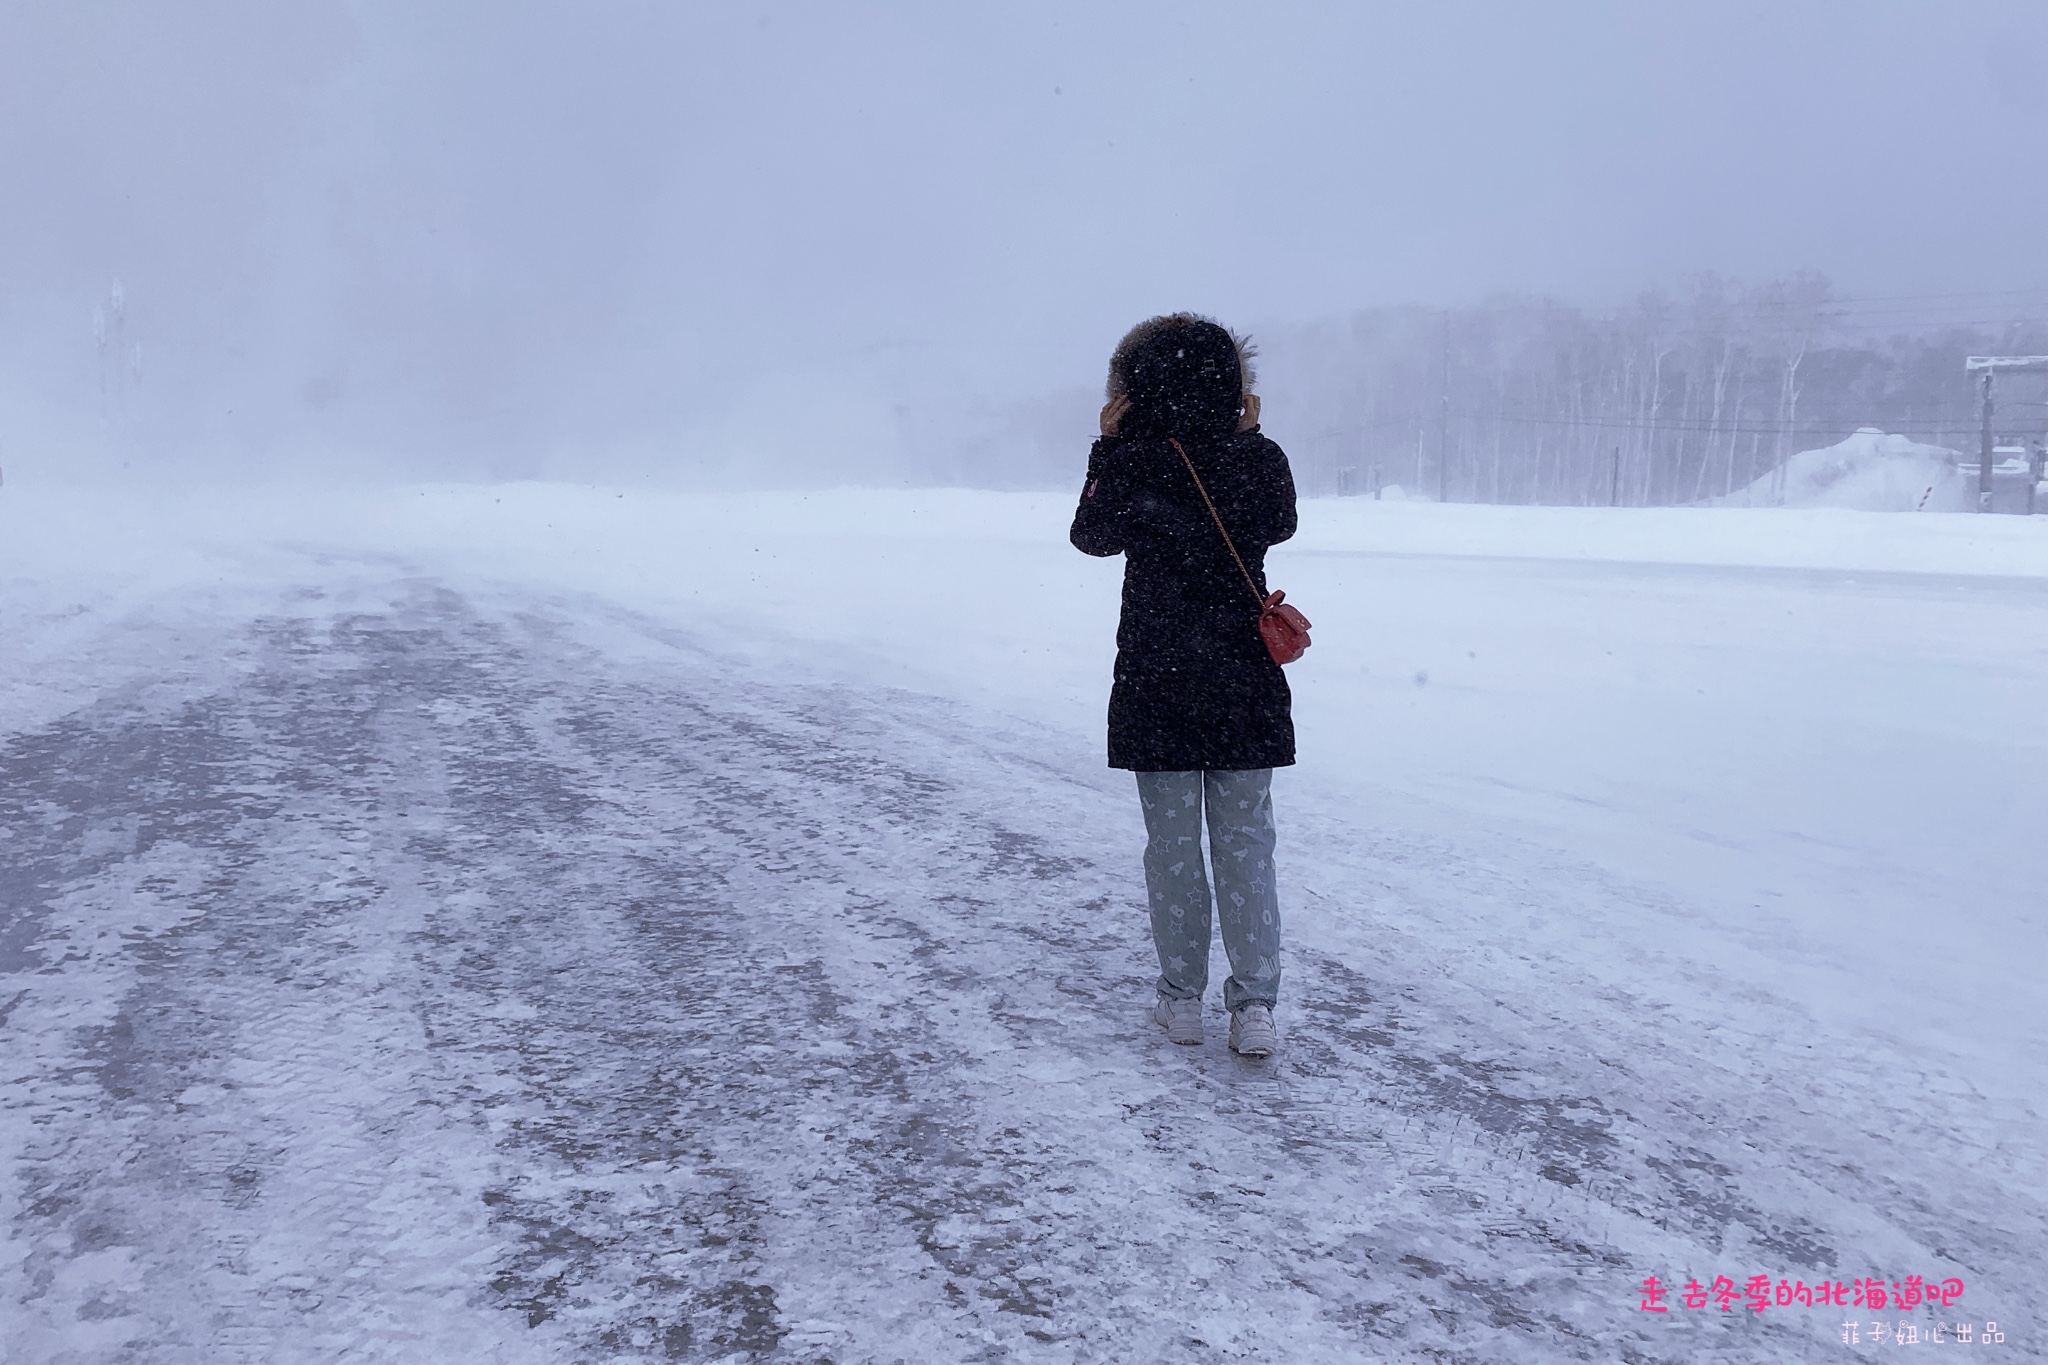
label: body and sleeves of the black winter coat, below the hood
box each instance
[1073,428,1294,772]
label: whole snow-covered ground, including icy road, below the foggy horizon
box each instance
[0,485,2048,1365]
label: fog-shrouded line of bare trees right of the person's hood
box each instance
[1266,272,2048,505]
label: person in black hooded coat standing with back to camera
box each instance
[1073,313,1294,1056]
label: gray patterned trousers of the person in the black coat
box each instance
[1137,767,1280,1009]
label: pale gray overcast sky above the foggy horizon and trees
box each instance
[0,0,2048,473]
